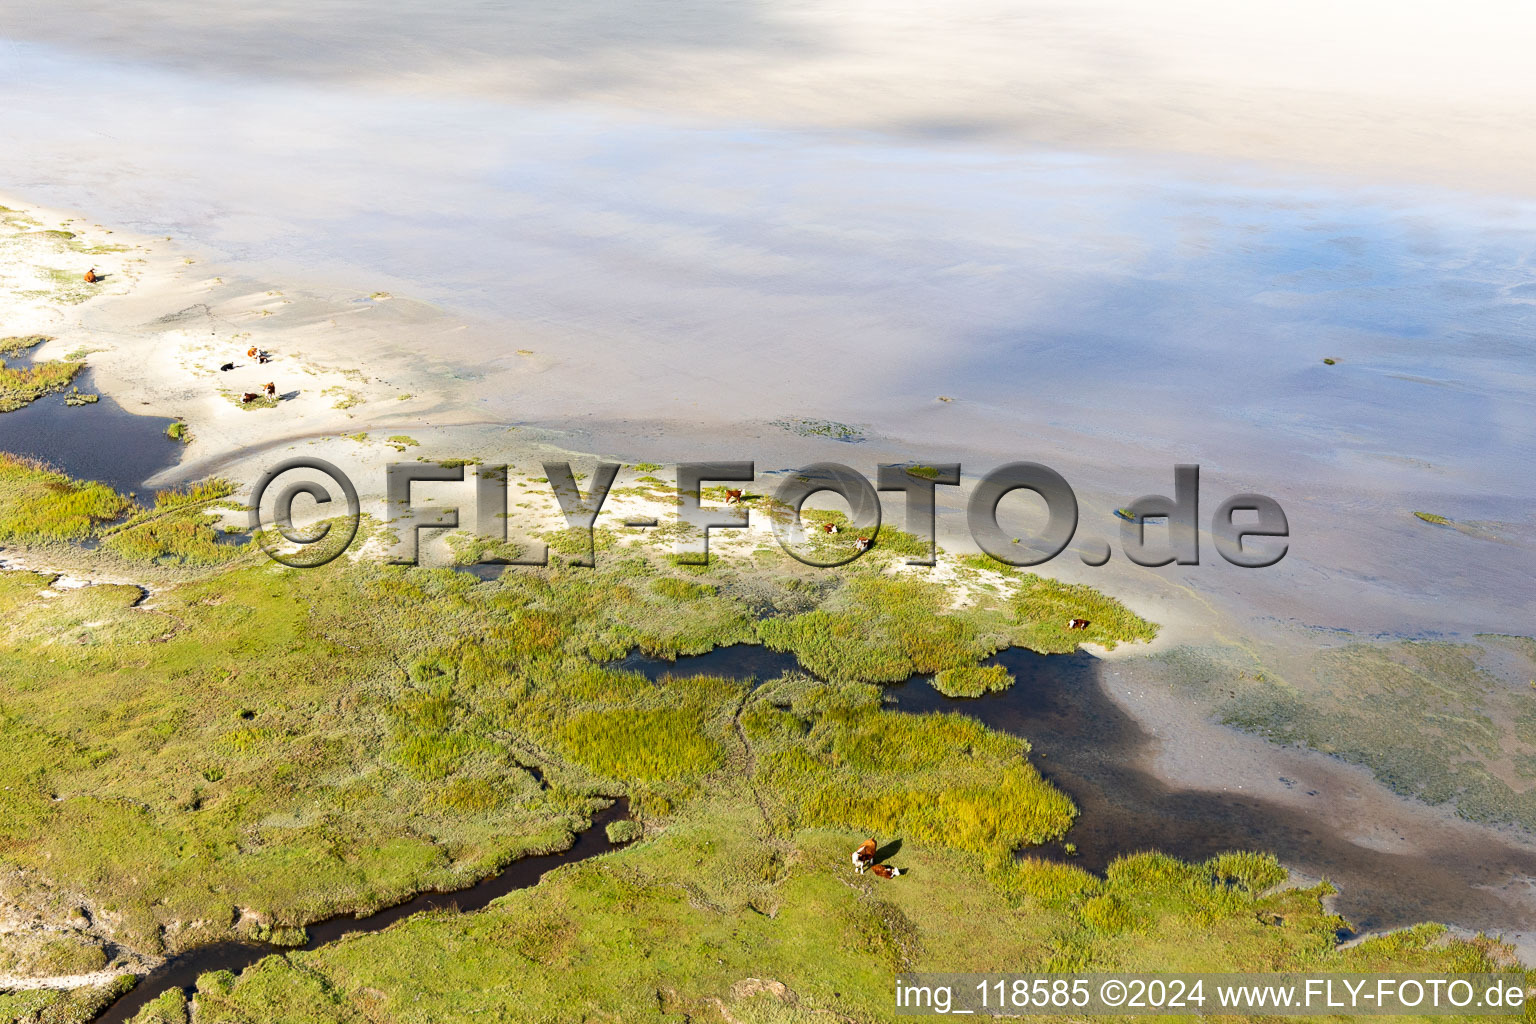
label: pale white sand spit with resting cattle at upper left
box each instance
[0,197,470,497]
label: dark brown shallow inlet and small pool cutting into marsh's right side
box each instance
[621,646,1536,933]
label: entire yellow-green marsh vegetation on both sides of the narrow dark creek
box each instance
[0,457,1523,1024]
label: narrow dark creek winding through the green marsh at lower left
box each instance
[95,797,630,1024]
